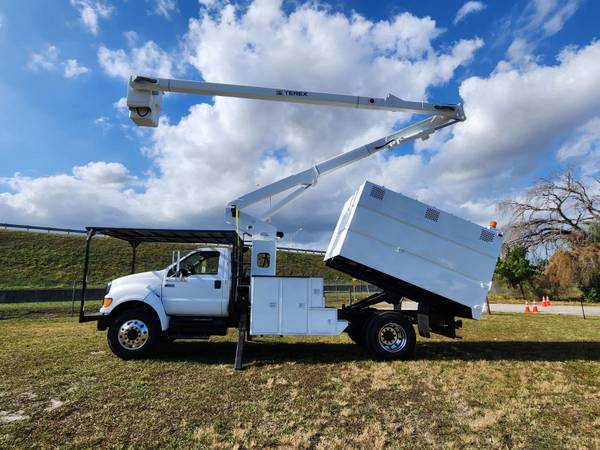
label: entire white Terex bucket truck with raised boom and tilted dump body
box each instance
[80,76,502,369]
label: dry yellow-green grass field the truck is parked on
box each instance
[0,302,600,449]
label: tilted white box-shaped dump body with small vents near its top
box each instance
[325,181,502,319]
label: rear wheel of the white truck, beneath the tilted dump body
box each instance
[364,312,417,360]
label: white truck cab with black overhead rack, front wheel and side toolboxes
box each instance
[80,228,348,359]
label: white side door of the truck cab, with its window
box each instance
[162,250,229,316]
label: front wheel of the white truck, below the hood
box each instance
[107,308,162,359]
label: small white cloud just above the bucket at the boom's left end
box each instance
[98,41,174,80]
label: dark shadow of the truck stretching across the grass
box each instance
[153,341,600,366]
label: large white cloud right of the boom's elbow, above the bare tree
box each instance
[406,42,600,214]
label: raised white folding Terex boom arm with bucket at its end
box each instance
[127,76,465,239]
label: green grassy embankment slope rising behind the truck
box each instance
[0,230,350,289]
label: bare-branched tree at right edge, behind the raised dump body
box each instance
[500,170,600,251]
